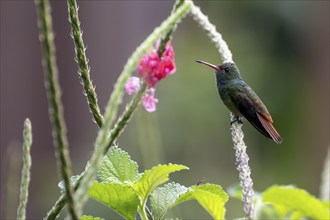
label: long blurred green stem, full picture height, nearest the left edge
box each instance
[35,0,78,219]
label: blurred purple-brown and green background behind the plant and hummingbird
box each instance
[0,0,329,219]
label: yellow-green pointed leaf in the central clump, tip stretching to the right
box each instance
[134,164,189,201]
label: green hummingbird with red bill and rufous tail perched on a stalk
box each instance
[196,60,283,144]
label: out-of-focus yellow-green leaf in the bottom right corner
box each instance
[263,186,330,219]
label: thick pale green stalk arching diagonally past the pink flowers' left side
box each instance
[75,2,191,217]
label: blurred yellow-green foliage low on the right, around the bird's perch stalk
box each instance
[228,184,330,219]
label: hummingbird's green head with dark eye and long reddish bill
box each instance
[196,60,241,81]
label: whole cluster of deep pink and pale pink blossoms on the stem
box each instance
[125,42,175,112]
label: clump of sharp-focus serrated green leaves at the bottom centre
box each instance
[88,147,228,219]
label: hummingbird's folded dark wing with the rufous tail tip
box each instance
[230,84,282,144]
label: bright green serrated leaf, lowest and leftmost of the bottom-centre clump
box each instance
[88,182,140,219]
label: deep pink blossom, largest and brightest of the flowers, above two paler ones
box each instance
[137,42,176,88]
